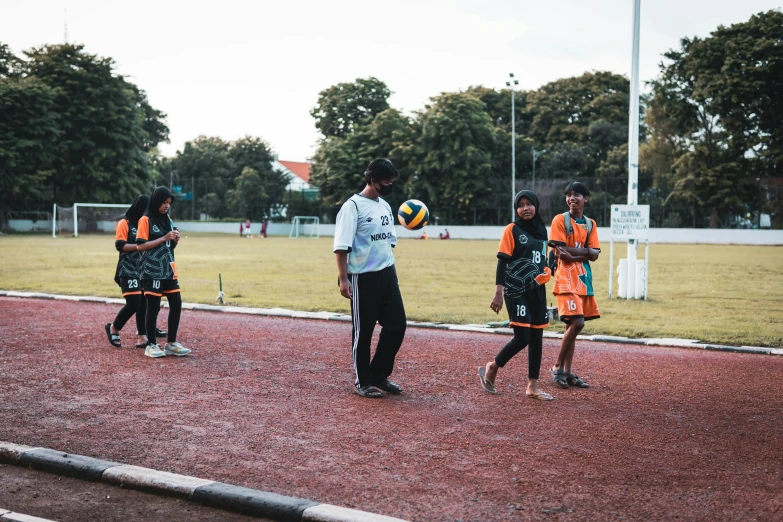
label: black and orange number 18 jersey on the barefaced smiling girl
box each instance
[495,223,547,297]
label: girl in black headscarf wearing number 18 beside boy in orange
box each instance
[478,190,553,401]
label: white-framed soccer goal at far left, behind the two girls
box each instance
[52,203,130,237]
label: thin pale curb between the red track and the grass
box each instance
[0,290,783,355]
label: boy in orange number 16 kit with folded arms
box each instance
[549,181,601,388]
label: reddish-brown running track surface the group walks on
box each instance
[0,298,783,521]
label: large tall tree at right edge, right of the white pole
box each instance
[651,11,783,227]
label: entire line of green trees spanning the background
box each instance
[0,10,783,227]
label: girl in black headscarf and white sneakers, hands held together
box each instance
[136,187,190,357]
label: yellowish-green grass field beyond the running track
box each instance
[0,234,783,346]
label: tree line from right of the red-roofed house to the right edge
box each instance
[311,10,783,227]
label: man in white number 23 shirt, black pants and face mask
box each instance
[333,159,406,399]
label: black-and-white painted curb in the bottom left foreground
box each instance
[0,441,405,522]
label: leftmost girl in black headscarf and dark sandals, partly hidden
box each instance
[104,195,158,348]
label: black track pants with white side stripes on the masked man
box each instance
[349,265,406,387]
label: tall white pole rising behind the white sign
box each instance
[626,0,641,299]
